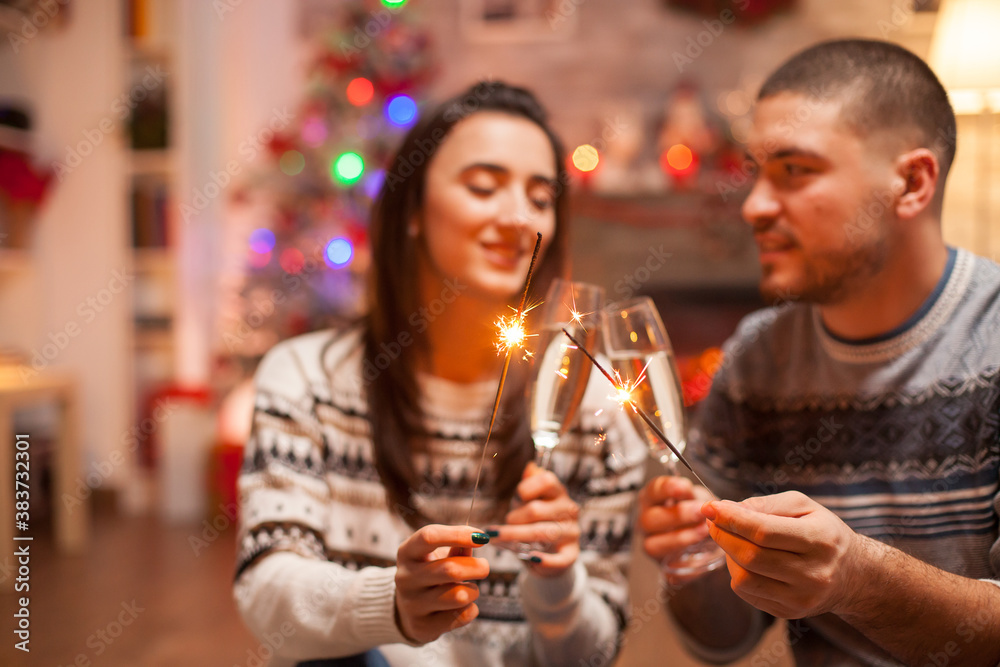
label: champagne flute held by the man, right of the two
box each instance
[604,297,726,577]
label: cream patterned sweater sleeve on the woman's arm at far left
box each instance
[234,341,414,660]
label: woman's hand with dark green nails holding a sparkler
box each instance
[396,525,490,644]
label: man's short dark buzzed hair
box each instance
[757,39,956,183]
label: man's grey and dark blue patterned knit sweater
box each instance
[690,249,1000,666]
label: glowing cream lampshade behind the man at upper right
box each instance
[929,0,1000,113]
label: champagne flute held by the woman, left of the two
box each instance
[504,279,604,559]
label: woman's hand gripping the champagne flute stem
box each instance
[490,463,580,577]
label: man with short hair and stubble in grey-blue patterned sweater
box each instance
[640,40,1000,667]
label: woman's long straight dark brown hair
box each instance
[362,81,568,527]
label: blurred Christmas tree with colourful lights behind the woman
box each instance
[221,0,434,379]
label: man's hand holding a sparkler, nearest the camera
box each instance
[702,491,866,618]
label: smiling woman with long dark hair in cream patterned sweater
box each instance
[236,82,642,666]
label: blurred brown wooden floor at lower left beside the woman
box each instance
[0,512,260,667]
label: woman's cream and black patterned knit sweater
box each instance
[235,329,645,667]
